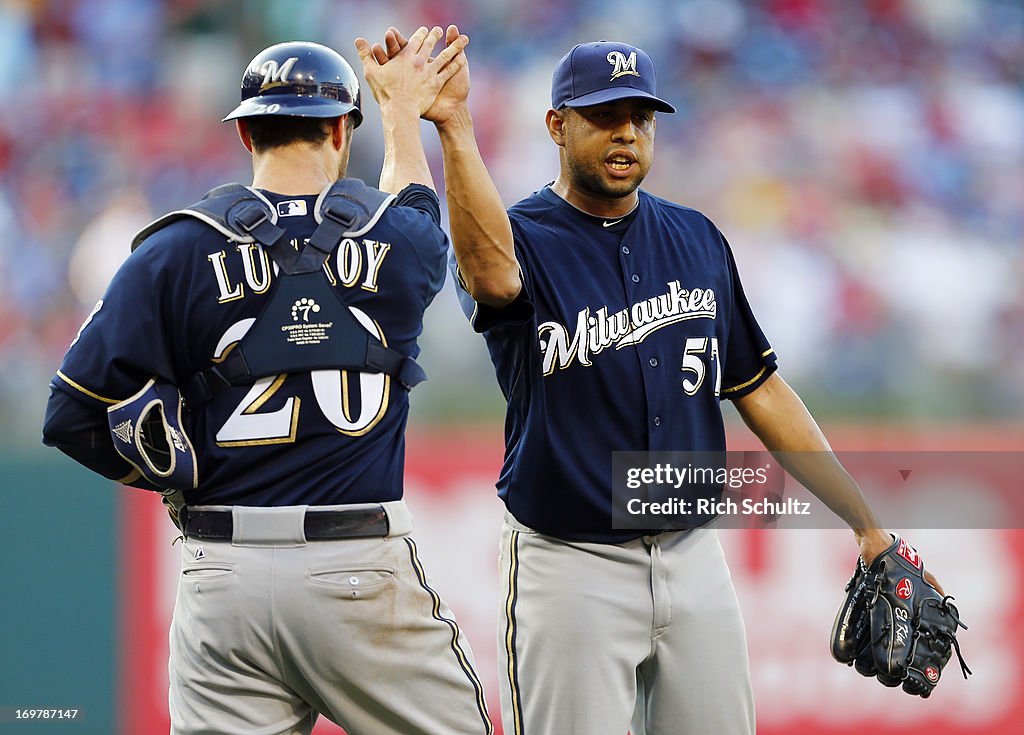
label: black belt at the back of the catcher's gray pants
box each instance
[178,506,388,542]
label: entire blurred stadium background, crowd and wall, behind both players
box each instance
[0,0,1024,735]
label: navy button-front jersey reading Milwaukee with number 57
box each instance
[457,187,775,543]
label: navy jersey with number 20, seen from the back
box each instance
[44,185,447,506]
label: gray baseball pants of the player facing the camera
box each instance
[499,513,755,735]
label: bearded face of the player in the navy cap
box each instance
[562,99,654,199]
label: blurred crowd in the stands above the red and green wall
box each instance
[0,0,1024,447]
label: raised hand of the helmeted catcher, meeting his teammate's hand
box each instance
[355,27,469,117]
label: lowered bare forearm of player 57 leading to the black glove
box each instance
[735,374,879,538]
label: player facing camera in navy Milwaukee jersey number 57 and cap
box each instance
[378,28,950,735]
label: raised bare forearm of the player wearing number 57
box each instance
[437,111,522,307]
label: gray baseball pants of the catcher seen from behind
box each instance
[168,502,493,735]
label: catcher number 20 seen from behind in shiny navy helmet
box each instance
[44,28,493,735]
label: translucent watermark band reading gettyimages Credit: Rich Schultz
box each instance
[611,450,1024,530]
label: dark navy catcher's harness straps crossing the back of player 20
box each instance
[132,178,427,406]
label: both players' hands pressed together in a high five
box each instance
[355,26,469,125]
